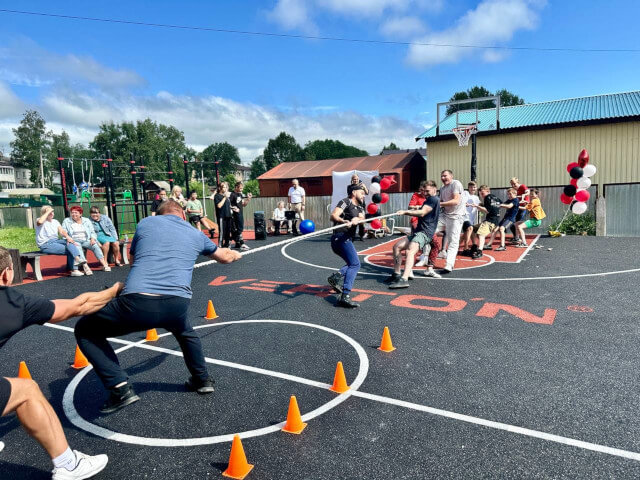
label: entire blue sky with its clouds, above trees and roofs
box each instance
[0,0,640,163]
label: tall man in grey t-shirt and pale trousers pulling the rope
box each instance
[436,170,467,273]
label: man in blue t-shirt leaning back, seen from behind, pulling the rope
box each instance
[75,200,241,413]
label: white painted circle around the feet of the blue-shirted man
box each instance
[62,320,369,447]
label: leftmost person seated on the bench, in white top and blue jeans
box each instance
[36,205,91,277]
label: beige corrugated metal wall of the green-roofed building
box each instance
[427,122,640,188]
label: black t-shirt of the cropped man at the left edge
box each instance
[0,287,56,348]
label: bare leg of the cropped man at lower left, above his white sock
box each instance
[2,378,69,459]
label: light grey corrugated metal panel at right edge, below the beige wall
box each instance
[604,184,640,237]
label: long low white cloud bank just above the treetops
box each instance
[28,90,422,163]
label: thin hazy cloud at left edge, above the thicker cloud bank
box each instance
[0,37,146,88]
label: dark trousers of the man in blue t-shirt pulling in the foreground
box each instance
[75,293,209,388]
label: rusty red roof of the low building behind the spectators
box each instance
[258,151,422,180]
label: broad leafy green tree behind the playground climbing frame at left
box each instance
[89,118,193,186]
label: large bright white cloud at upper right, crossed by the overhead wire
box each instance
[407,0,546,67]
